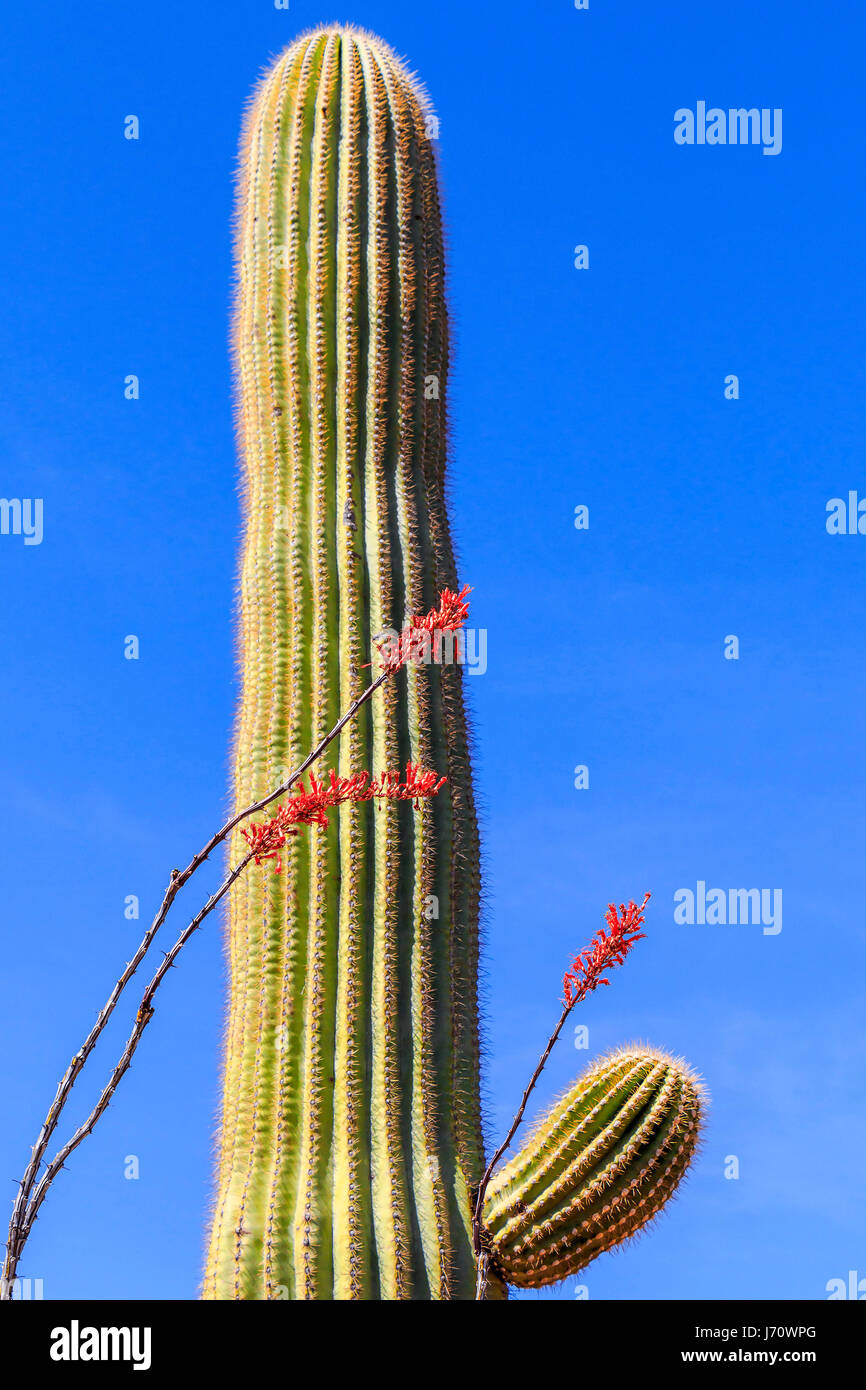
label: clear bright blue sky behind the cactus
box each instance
[0,0,866,1300]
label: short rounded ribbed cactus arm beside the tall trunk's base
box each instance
[484,1048,703,1289]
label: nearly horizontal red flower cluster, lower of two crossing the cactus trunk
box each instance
[240,763,448,873]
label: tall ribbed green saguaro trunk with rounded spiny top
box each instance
[203,28,482,1300]
